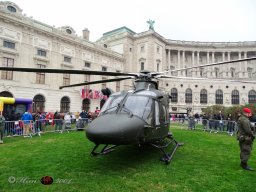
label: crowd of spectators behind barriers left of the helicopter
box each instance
[0,107,100,144]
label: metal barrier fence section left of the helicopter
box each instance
[2,118,91,137]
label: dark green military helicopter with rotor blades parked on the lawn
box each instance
[0,57,256,164]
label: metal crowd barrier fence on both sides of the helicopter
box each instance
[2,118,256,137]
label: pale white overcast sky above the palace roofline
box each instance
[10,0,256,42]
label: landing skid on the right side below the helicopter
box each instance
[151,133,184,164]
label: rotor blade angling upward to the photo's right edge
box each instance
[159,57,256,76]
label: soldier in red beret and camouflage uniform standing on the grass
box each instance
[237,108,254,171]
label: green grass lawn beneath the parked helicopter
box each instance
[0,126,256,192]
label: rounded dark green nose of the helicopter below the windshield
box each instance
[86,114,145,145]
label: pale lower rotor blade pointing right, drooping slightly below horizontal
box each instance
[157,75,256,83]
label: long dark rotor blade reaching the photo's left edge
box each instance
[0,67,138,77]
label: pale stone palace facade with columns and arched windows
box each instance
[0,1,256,113]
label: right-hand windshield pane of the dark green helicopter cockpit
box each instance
[121,95,153,124]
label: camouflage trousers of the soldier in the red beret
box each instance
[239,136,253,165]
